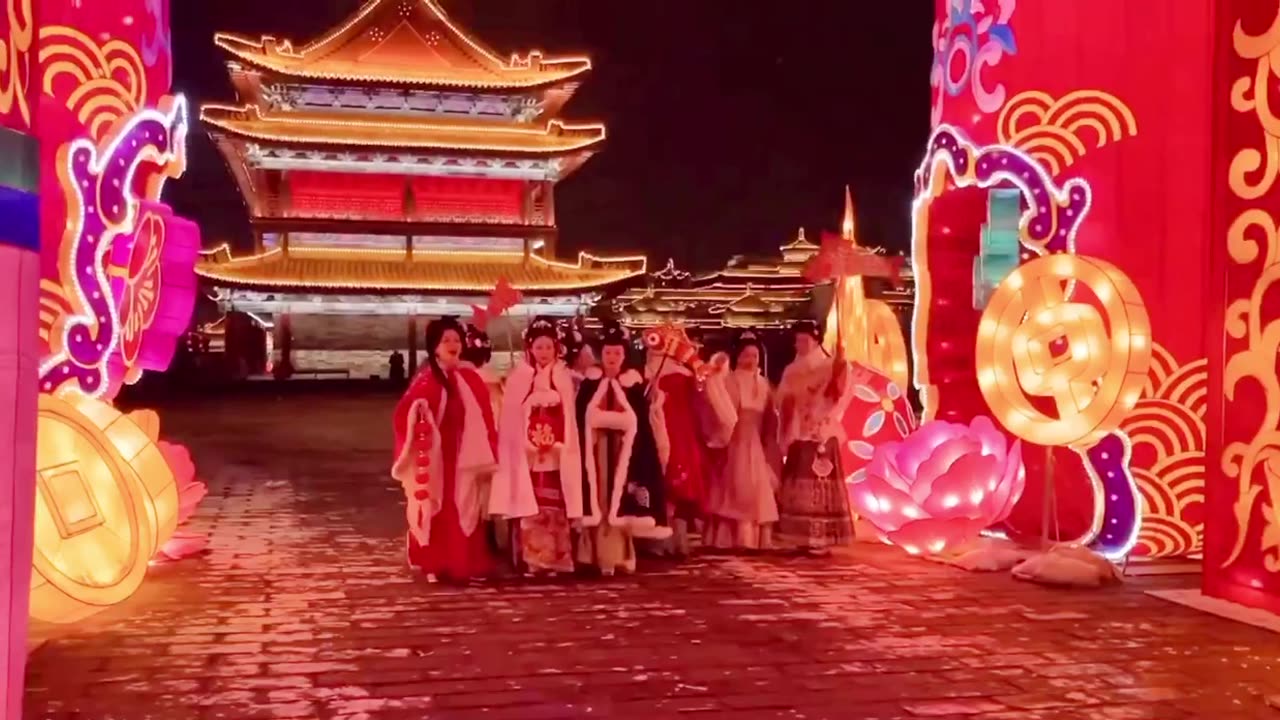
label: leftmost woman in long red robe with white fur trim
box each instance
[392,318,498,582]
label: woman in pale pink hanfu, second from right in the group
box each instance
[703,331,782,550]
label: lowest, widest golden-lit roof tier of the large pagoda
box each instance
[196,246,645,293]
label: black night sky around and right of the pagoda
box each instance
[170,0,933,269]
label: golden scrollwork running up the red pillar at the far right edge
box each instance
[1221,4,1280,573]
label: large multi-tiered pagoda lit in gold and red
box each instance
[198,0,645,379]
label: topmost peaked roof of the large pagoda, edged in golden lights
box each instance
[214,0,591,90]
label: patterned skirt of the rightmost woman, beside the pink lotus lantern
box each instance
[778,438,854,548]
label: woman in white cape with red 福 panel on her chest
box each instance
[489,318,600,574]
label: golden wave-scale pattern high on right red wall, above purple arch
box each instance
[996,90,1138,177]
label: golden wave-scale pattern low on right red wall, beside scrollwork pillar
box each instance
[1120,343,1208,557]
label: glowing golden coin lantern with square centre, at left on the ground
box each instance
[31,395,178,623]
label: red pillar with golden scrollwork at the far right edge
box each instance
[1204,0,1280,612]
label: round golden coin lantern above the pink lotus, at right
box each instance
[977,255,1151,448]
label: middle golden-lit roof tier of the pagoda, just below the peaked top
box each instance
[200,105,605,155]
